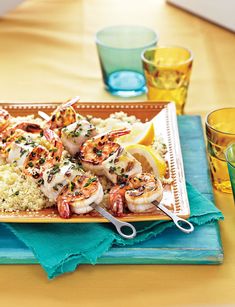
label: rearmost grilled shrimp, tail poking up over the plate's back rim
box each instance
[46,97,79,135]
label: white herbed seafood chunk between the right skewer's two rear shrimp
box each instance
[61,119,96,156]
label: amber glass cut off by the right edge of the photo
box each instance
[206,108,235,193]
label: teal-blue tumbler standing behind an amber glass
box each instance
[96,25,158,97]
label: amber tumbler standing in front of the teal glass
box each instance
[141,46,193,114]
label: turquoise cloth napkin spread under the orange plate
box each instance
[5,184,223,279]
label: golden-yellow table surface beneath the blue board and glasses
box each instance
[0,0,235,307]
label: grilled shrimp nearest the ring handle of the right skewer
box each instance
[109,173,163,216]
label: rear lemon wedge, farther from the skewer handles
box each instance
[117,122,154,147]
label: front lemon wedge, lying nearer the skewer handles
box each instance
[125,144,167,178]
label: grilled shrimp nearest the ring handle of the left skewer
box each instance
[57,175,103,218]
